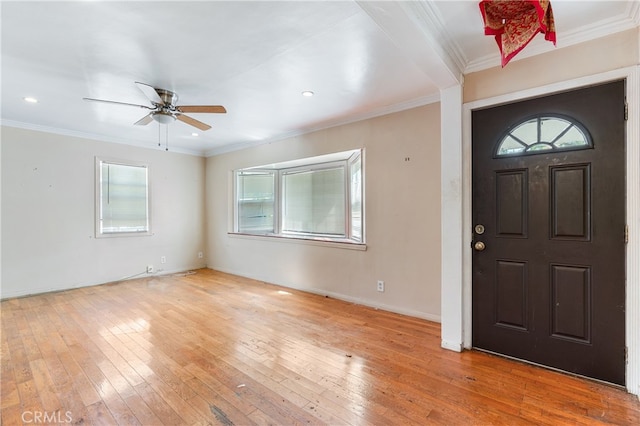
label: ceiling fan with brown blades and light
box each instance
[83,81,227,131]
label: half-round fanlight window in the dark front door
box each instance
[496,115,593,157]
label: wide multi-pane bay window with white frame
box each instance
[234,150,364,243]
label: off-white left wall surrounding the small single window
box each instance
[0,127,206,298]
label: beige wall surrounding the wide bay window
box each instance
[207,103,440,321]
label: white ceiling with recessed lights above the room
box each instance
[0,0,640,155]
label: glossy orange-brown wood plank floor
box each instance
[0,269,640,425]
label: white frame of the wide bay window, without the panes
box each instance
[234,149,365,246]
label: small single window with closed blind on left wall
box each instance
[96,158,150,237]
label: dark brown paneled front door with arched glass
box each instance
[472,81,625,385]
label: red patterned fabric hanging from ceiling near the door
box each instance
[480,0,556,67]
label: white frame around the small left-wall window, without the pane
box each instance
[94,156,152,238]
